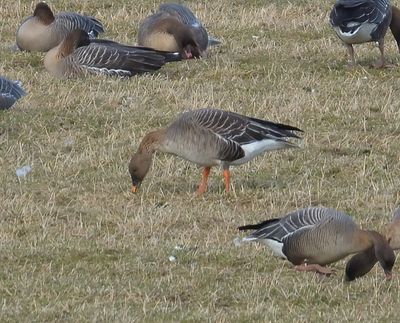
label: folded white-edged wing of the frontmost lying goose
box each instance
[67,43,165,76]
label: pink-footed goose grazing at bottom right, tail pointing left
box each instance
[238,207,395,280]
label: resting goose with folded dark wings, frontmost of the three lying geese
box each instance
[44,29,181,78]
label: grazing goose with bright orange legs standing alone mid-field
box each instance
[129,109,301,194]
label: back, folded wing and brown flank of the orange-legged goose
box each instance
[161,109,300,166]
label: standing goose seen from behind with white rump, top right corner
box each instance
[330,0,392,67]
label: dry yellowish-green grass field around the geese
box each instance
[0,0,400,322]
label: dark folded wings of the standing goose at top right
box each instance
[330,0,390,28]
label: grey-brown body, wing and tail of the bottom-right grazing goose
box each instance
[239,207,358,265]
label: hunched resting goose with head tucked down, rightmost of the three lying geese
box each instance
[138,3,220,59]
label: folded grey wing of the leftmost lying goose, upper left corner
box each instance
[55,12,104,38]
